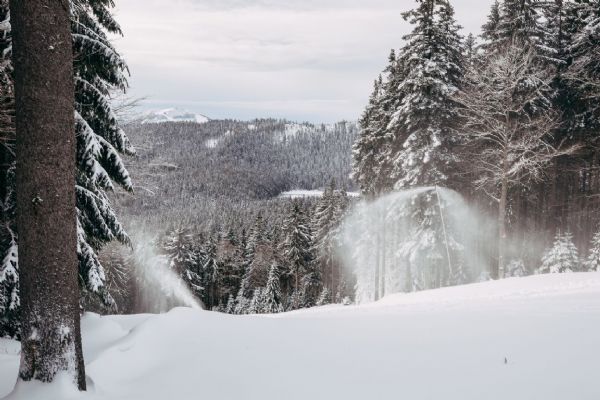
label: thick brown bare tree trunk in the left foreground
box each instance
[10,0,86,390]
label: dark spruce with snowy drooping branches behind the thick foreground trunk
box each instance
[0,0,134,329]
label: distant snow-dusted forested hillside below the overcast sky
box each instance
[118,119,357,229]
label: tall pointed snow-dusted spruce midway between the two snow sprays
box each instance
[281,200,313,308]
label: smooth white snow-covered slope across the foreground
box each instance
[0,273,600,400]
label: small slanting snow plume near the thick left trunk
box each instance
[134,234,203,313]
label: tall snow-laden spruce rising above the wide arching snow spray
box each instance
[390,0,463,188]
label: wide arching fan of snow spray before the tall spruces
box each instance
[339,187,496,303]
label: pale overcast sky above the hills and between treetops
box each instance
[116,0,492,122]
